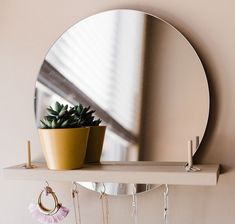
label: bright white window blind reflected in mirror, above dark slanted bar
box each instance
[46,12,144,134]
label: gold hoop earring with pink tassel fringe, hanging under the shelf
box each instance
[29,182,69,224]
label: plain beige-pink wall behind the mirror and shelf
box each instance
[0,0,235,224]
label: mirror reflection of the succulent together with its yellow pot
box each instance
[74,104,106,163]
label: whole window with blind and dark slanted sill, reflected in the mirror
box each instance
[35,11,145,165]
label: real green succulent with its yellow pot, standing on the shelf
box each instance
[39,102,90,170]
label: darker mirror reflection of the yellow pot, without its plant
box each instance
[85,126,106,163]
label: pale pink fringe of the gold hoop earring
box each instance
[29,203,69,224]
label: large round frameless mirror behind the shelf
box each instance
[35,10,209,195]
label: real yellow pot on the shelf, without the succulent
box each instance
[39,128,90,170]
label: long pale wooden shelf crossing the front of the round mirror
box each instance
[3,162,219,186]
